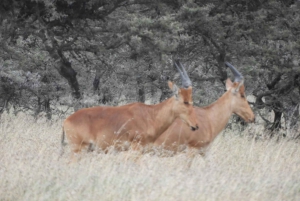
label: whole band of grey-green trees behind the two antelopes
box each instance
[0,0,300,133]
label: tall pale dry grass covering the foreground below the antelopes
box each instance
[0,111,300,201]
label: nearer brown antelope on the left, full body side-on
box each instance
[62,62,198,158]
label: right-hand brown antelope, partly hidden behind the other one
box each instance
[154,62,255,151]
